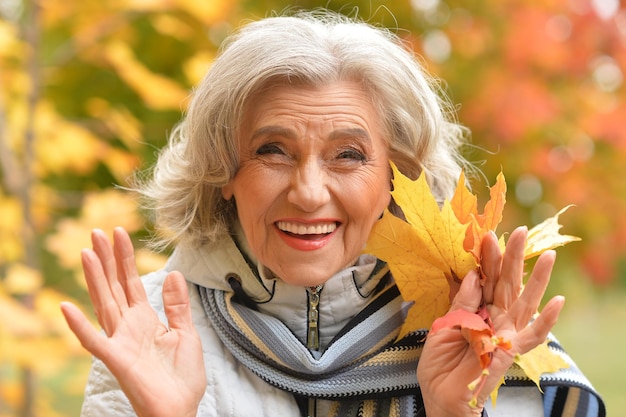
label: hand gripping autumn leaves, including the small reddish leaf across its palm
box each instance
[417,228,563,416]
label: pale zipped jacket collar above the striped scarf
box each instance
[167,224,388,346]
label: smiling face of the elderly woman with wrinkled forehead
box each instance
[222,82,390,286]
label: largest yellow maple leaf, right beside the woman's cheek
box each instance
[364,164,476,336]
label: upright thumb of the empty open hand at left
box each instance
[163,271,193,331]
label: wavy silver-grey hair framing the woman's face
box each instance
[138,11,466,246]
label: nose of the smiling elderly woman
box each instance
[287,159,330,213]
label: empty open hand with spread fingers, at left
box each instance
[61,228,206,417]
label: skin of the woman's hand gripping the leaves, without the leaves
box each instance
[417,227,564,417]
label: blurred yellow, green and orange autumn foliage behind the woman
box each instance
[0,0,626,417]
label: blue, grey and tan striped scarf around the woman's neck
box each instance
[198,268,606,417]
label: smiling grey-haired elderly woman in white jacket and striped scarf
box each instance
[62,8,604,417]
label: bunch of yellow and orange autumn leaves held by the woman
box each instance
[364,164,580,402]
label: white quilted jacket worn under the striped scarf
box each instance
[81,231,543,417]
